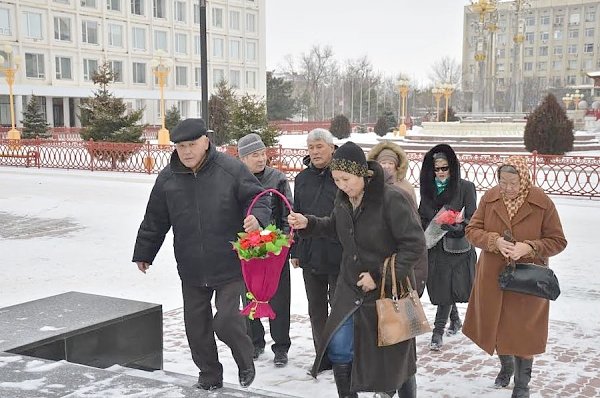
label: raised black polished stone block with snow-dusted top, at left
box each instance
[0,292,163,369]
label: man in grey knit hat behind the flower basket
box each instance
[238,133,294,367]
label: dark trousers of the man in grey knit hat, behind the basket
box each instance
[244,260,292,352]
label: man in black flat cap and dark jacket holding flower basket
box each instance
[133,119,271,390]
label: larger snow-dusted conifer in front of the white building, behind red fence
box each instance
[80,62,144,142]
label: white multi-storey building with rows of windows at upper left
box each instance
[0,0,266,127]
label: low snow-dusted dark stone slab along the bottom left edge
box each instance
[0,352,298,398]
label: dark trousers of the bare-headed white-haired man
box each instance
[302,269,338,352]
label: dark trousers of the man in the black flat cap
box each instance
[181,280,253,384]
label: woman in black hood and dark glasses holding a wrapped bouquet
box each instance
[419,144,477,351]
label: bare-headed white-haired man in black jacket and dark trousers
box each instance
[290,128,342,368]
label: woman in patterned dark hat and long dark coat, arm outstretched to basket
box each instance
[288,142,426,398]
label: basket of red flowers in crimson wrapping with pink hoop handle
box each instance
[233,189,293,319]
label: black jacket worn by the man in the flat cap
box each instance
[132,145,271,287]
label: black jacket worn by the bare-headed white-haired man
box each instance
[290,156,342,275]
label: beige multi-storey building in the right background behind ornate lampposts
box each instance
[462,0,600,109]
